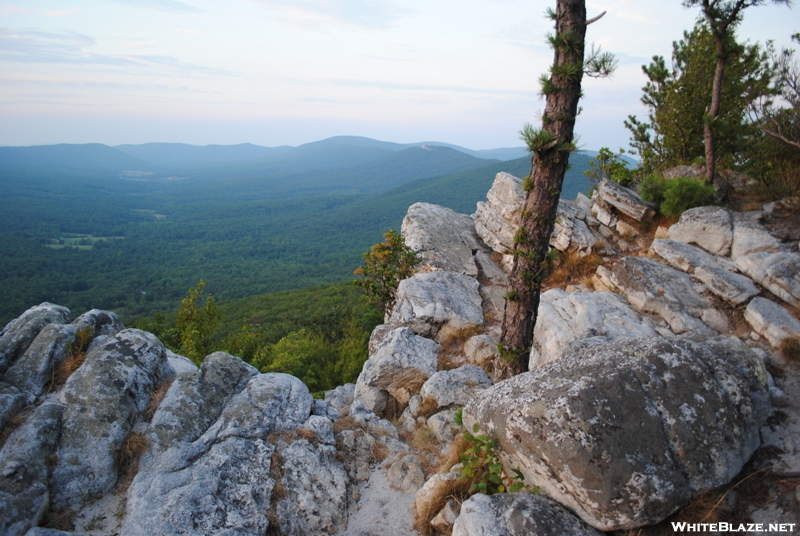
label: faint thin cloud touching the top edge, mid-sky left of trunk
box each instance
[250,0,410,29]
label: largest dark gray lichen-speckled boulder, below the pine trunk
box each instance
[464,338,770,531]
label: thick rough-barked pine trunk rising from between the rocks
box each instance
[496,0,586,378]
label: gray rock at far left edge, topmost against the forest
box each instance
[0,302,69,378]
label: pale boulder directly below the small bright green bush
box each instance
[669,207,733,256]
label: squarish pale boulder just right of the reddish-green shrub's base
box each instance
[389,272,483,336]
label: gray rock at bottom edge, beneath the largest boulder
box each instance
[453,492,601,536]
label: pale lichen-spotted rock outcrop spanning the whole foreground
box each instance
[0,168,800,536]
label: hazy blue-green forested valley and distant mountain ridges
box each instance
[0,138,589,324]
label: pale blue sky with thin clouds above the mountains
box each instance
[0,0,800,150]
